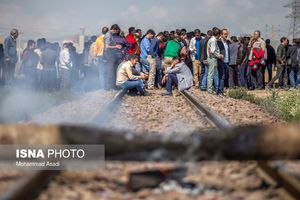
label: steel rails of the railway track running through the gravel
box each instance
[0,90,300,200]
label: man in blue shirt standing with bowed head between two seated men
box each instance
[140,29,155,87]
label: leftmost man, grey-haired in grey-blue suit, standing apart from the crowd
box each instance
[4,29,19,84]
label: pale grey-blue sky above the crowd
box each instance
[0,0,290,42]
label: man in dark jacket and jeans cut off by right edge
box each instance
[286,39,300,88]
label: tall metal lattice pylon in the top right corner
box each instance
[283,0,300,38]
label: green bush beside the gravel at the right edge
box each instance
[228,88,300,122]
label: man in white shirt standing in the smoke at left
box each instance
[59,43,72,89]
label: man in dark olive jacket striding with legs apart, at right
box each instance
[266,37,287,90]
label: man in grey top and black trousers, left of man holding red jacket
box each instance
[228,36,241,87]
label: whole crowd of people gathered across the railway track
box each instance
[0,24,300,96]
